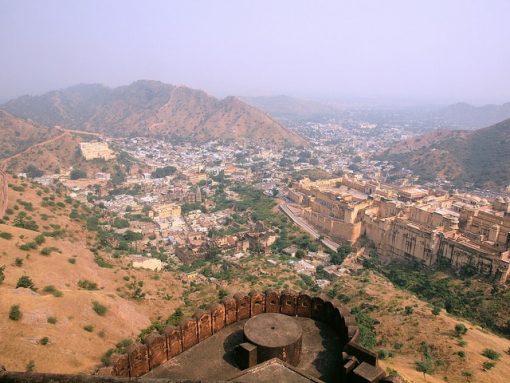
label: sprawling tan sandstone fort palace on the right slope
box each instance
[288,176,510,283]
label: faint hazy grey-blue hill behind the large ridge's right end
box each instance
[241,95,340,120]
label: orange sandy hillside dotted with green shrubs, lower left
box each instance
[0,177,182,373]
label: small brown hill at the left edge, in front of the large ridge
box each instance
[0,110,59,159]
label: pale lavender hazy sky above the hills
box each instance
[0,0,510,104]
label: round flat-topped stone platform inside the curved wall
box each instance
[244,313,303,366]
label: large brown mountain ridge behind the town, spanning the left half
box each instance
[1,80,307,146]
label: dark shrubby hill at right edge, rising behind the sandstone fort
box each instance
[376,119,510,187]
